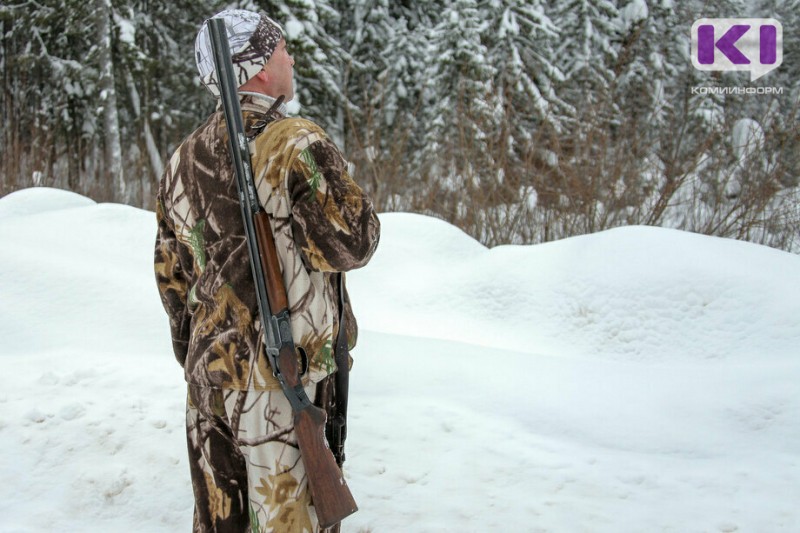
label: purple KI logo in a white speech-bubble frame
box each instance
[692,19,783,81]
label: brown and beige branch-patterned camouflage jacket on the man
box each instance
[155,96,380,390]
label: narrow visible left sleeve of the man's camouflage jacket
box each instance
[155,194,190,366]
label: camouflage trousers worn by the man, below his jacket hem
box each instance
[186,385,332,533]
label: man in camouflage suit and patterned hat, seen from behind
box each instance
[155,10,380,532]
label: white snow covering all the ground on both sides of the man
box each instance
[0,188,800,533]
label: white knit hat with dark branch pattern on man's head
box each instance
[194,9,283,97]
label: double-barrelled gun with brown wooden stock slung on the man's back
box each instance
[208,18,358,529]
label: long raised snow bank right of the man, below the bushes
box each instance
[351,214,800,360]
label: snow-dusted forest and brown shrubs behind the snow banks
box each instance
[0,0,800,249]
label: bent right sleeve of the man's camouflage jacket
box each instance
[288,137,380,272]
